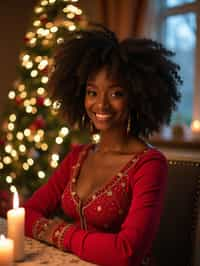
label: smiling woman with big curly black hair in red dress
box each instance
[25,25,181,266]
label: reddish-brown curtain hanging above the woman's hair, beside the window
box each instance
[99,0,152,39]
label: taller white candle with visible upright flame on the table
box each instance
[7,191,25,261]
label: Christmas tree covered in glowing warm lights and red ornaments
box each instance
[0,0,87,200]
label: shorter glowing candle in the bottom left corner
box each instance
[0,235,13,266]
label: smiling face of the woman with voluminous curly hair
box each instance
[85,69,128,131]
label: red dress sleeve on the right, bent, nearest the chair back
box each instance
[61,154,167,266]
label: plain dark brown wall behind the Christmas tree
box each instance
[0,0,100,120]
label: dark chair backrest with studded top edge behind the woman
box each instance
[153,160,200,266]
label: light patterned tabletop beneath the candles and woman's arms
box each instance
[0,218,94,266]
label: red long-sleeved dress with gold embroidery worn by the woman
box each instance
[25,145,167,266]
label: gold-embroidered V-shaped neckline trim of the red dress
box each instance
[71,144,150,207]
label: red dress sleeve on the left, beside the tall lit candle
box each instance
[24,148,80,237]
